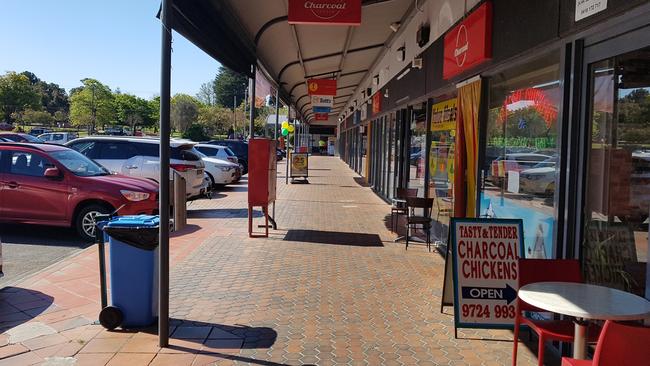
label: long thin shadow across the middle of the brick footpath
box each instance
[283,230,384,247]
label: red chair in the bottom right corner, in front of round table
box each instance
[562,320,650,366]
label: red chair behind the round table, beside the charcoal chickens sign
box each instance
[512,259,600,366]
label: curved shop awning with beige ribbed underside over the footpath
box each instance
[165,0,414,125]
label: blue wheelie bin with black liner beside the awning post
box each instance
[99,215,160,329]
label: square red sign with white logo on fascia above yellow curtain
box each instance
[442,2,492,79]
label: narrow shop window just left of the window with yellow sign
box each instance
[408,104,427,197]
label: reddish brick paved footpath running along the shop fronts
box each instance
[0,157,557,366]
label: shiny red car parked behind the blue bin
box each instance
[0,142,158,240]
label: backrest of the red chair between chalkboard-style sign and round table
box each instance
[517,260,583,311]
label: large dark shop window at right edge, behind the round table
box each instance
[582,47,650,296]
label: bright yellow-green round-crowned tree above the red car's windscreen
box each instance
[70,79,115,133]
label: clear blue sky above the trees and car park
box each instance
[0,0,219,98]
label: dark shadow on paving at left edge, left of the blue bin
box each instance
[0,286,54,333]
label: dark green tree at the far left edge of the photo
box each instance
[0,71,41,123]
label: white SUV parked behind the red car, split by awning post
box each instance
[66,136,209,199]
